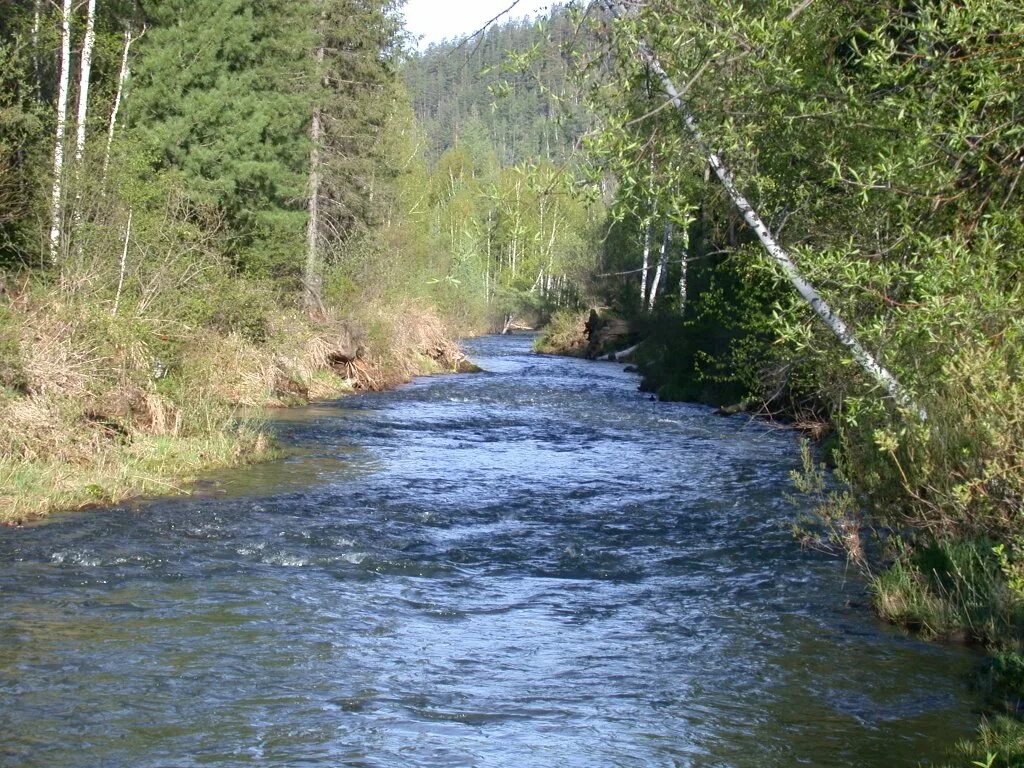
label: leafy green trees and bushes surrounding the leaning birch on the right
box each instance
[581,0,1024,552]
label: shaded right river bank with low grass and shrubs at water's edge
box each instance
[536,311,1024,768]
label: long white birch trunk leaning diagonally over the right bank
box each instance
[605,0,928,420]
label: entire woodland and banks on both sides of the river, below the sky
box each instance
[0,0,1024,768]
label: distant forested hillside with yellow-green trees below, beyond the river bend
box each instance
[402,10,604,328]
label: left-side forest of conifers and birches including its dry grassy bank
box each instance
[0,0,593,521]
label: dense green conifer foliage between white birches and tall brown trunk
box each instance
[130,0,315,274]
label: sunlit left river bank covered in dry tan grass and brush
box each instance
[0,286,466,525]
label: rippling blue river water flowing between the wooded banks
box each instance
[0,337,978,768]
